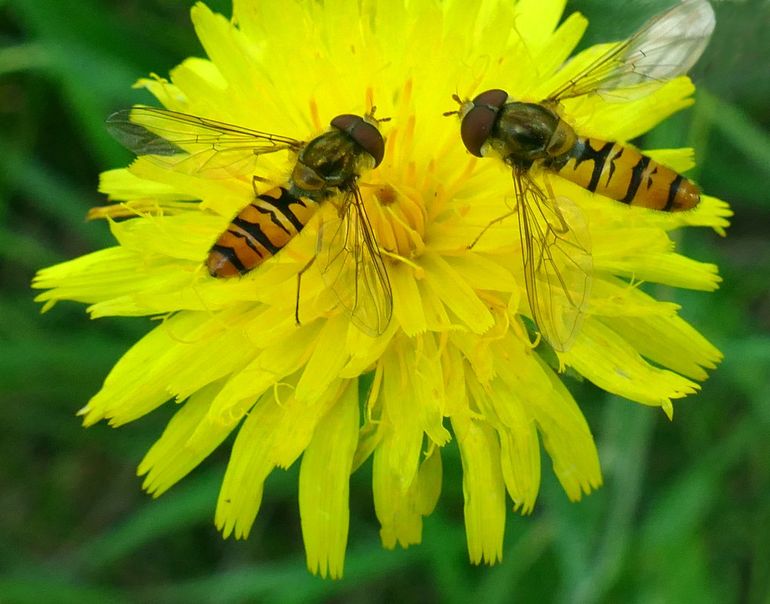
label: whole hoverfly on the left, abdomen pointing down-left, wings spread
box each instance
[107,106,392,335]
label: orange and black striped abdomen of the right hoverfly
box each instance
[545,137,700,212]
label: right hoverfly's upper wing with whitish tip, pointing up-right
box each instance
[546,0,714,102]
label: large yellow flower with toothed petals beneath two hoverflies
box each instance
[34,0,729,577]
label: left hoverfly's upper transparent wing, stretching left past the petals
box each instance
[107,107,303,178]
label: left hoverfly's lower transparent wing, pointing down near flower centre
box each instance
[319,185,393,336]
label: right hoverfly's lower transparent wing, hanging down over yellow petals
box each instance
[513,168,593,351]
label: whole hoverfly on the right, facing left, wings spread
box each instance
[447,0,714,351]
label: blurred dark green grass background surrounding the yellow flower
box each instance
[0,0,770,603]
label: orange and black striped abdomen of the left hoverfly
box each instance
[206,187,318,278]
